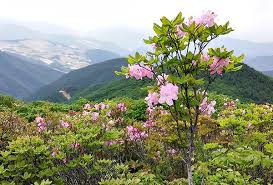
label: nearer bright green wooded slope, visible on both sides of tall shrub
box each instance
[77,65,273,103]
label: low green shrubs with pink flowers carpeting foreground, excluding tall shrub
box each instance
[0,96,273,185]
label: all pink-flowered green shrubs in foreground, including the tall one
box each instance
[0,12,273,185]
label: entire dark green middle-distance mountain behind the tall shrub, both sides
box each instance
[29,58,273,103]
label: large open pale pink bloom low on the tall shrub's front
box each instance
[158,83,178,106]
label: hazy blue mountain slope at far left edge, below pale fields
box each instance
[0,51,63,98]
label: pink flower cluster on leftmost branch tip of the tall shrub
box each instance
[128,64,153,80]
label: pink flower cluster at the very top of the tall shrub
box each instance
[188,11,217,27]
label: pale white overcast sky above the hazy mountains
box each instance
[0,0,273,42]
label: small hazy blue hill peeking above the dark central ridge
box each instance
[85,49,120,64]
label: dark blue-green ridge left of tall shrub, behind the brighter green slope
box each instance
[27,58,127,102]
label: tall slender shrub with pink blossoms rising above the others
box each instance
[118,11,243,185]
